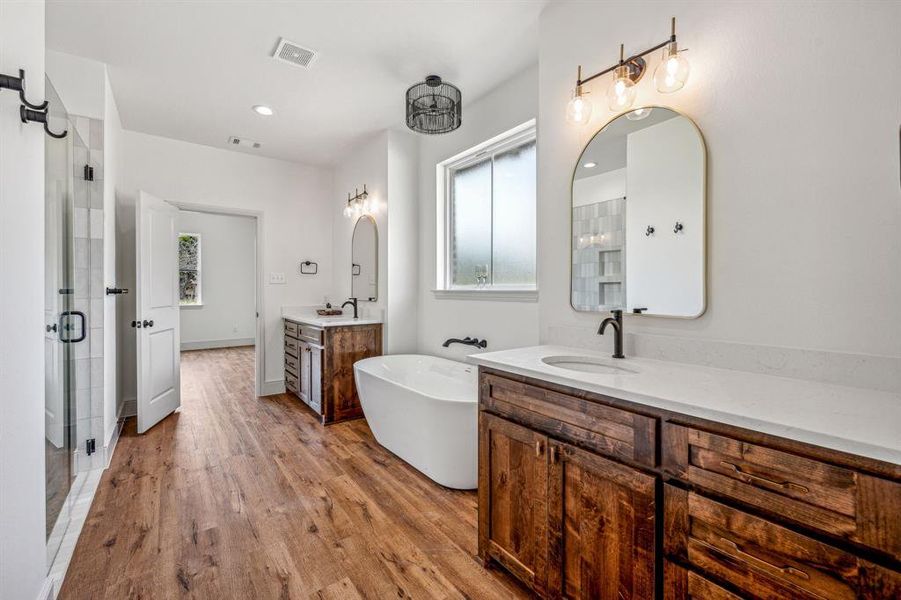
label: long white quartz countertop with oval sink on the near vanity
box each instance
[468,346,901,465]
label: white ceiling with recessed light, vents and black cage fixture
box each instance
[47,0,545,165]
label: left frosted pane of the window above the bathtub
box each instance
[450,159,491,285]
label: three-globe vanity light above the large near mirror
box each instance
[566,17,689,124]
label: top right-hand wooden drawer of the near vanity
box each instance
[662,423,901,560]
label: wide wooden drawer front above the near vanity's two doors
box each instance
[480,374,657,467]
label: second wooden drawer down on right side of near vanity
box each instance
[663,484,901,600]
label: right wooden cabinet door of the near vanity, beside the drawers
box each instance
[548,440,655,600]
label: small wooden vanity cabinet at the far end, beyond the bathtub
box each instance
[285,320,382,424]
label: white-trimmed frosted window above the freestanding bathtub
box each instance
[437,120,537,293]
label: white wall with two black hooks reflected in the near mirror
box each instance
[626,117,704,317]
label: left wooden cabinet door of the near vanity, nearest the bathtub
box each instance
[479,412,548,595]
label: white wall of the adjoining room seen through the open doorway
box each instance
[178,211,257,350]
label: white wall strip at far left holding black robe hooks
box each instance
[0,2,47,600]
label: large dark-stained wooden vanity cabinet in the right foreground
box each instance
[479,367,901,600]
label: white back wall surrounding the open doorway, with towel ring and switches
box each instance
[117,131,332,399]
